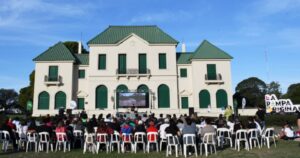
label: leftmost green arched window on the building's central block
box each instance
[96,85,108,109]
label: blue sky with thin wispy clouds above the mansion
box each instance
[0,0,300,92]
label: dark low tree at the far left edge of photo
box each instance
[0,88,18,107]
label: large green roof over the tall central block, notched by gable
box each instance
[88,25,178,44]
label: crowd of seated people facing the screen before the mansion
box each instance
[0,111,276,152]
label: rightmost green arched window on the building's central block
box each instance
[157,84,170,108]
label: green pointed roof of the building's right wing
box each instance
[192,40,233,59]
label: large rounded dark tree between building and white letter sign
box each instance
[235,77,267,107]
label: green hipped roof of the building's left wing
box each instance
[33,42,76,61]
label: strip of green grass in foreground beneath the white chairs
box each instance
[0,140,300,158]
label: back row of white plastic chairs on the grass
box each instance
[0,128,276,157]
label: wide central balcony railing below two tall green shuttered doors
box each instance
[116,69,151,79]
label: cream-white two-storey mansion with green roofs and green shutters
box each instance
[33,26,232,116]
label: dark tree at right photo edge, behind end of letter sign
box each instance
[283,83,300,104]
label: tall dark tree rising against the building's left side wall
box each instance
[19,71,35,107]
